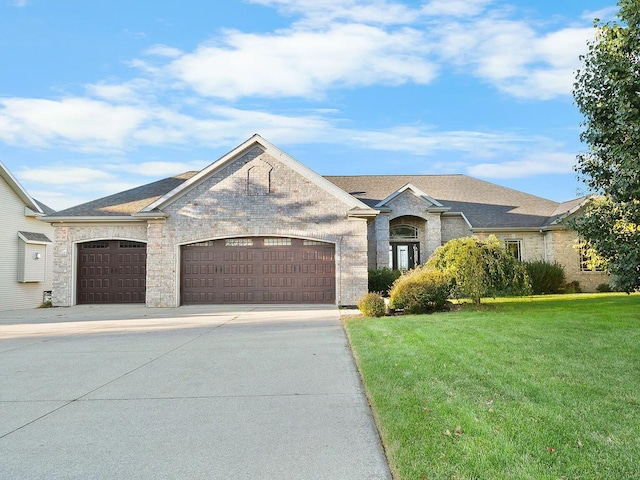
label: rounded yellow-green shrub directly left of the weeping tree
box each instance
[389,267,451,313]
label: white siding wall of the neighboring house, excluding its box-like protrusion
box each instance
[0,178,54,310]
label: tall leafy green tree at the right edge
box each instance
[571,0,640,292]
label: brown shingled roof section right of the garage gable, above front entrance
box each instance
[325,175,575,229]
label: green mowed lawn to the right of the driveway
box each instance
[345,294,640,480]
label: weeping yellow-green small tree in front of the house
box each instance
[426,235,530,304]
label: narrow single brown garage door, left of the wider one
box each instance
[78,240,147,304]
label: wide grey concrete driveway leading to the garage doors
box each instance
[0,306,390,480]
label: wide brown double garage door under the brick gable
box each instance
[181,237,336,305]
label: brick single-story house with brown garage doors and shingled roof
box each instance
[44,135,603,307]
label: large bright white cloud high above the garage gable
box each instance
[167,24,435,99]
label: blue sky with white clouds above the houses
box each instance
[0,0,616,209]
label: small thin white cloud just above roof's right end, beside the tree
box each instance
[467,152,576,178]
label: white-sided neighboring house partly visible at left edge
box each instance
[0,162,54,310]
